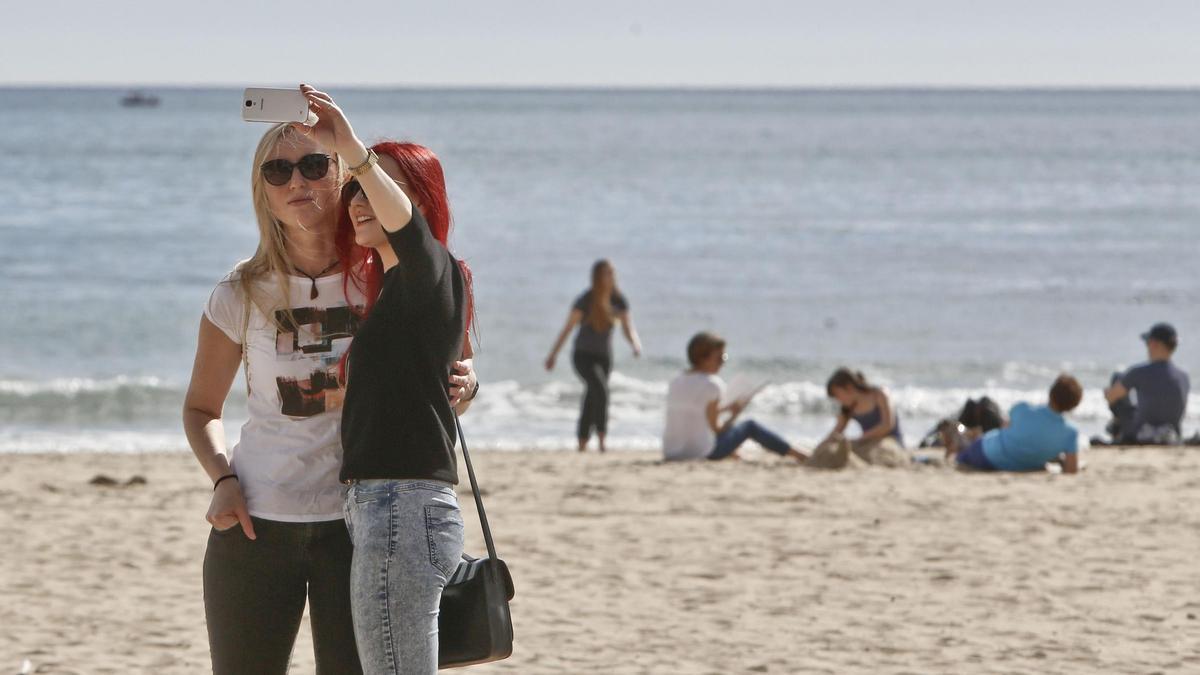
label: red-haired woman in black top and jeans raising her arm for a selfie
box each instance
[310,91,482,674]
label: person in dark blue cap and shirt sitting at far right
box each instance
[1104,323,1192,446]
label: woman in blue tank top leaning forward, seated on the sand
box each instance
[810,368,912,466]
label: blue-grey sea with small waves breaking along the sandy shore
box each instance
[0,83,1200,453]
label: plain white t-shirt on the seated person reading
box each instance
[662,371,725,460]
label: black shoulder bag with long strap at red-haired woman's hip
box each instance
[438,416,514,668]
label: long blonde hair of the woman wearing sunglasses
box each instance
[234,124,346,329]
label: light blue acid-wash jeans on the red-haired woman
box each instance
[346,480,463,675]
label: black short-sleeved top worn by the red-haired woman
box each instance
[341,207,467,484]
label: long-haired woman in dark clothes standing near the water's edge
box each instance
[546,259,642,453]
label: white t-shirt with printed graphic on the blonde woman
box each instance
[204,267,365,522]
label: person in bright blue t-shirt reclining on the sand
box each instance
[943,374,1084,473]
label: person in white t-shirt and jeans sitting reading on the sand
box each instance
[662,333,808,461]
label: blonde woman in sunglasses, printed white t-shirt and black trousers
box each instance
[184,86,476,675]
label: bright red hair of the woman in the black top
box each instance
[336,141,475,372]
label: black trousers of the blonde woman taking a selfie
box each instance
[204,518,362,675]
